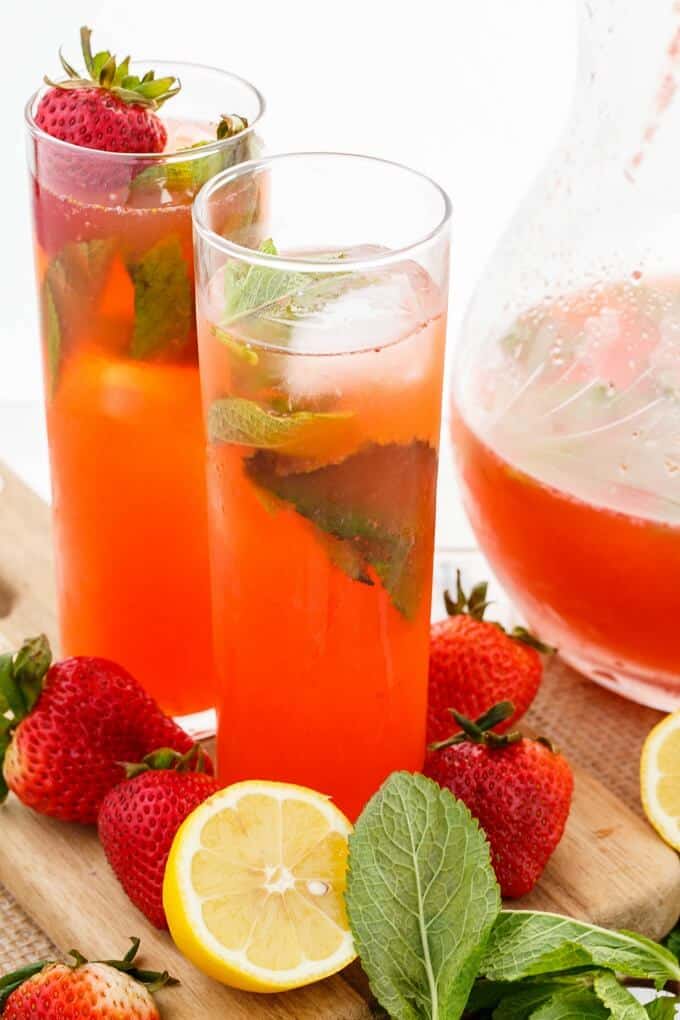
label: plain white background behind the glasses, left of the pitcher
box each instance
[0,0,580,505]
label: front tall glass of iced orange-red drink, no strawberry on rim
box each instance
[194,154,450,816]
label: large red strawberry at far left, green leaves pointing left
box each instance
[0,636,212,823]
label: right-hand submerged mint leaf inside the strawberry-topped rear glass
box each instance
[130,237,194,358]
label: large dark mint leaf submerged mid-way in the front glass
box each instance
[244,441,436,618]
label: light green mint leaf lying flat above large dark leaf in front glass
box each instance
[208,397,353,451]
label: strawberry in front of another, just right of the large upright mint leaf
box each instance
[425,702,574,899]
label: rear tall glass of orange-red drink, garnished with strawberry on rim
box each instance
[27,63,263,729]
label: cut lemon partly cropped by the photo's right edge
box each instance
[640,710,680,850]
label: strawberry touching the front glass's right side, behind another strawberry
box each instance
[427,570,554,742]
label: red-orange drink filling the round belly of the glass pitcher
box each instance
[454,279,680,705]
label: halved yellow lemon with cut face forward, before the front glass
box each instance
[163,781,356,991]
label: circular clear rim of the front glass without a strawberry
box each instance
[192,150,452,273]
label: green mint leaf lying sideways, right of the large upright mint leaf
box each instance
[480,910,680,987]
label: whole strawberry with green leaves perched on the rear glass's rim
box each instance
[35,28,179,152]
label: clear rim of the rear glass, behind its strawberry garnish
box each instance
[23,57,267,163]
